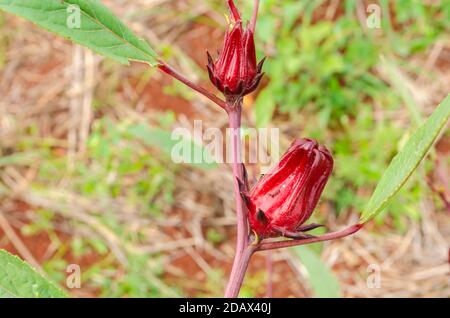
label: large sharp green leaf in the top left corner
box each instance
[0,0,158,66]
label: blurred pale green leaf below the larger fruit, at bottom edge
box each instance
[293,246,341,298]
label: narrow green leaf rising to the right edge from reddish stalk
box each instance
[361,95,450,223]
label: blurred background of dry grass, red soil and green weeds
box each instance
[0,0,450,297]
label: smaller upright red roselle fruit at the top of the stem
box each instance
[207,0,264,97]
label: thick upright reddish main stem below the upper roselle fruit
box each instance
[225,105,253,298]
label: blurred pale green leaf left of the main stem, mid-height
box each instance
[128,124,217,169]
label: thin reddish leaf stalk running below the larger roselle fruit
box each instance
[256,224,364,251]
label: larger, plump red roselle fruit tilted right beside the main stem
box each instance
[243,139,333,239]
